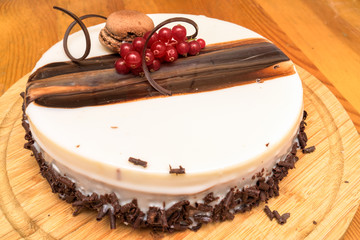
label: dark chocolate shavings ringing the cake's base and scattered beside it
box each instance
[22,101,315,234]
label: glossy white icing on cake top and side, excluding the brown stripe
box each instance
[26,14,303,207]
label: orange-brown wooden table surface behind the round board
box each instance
[0,0,360,240]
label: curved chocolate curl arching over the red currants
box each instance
[141,17,199,96]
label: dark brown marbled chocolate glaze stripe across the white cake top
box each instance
[25,40,295,108]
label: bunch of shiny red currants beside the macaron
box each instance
[115,25,205,75]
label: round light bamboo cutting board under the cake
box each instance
[0,67,360,239]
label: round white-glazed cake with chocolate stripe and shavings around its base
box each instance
[23,14,306,231]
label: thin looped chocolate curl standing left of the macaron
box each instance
[53,6,106,62]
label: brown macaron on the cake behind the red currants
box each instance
[99,10,154,52]
